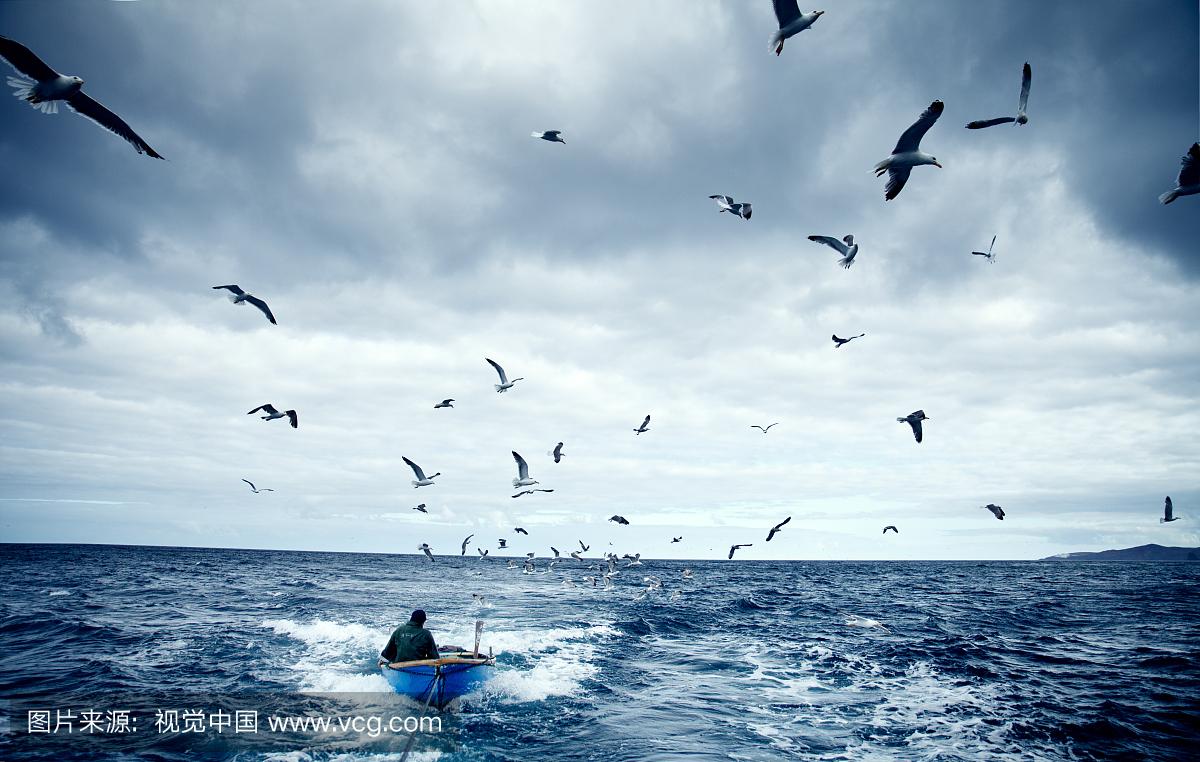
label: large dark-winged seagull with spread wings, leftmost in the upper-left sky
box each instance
[0,36,162,158]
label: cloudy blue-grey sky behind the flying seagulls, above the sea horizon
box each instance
[0,0,1200,559]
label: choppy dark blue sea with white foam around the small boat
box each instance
[0,545,1200,762]
